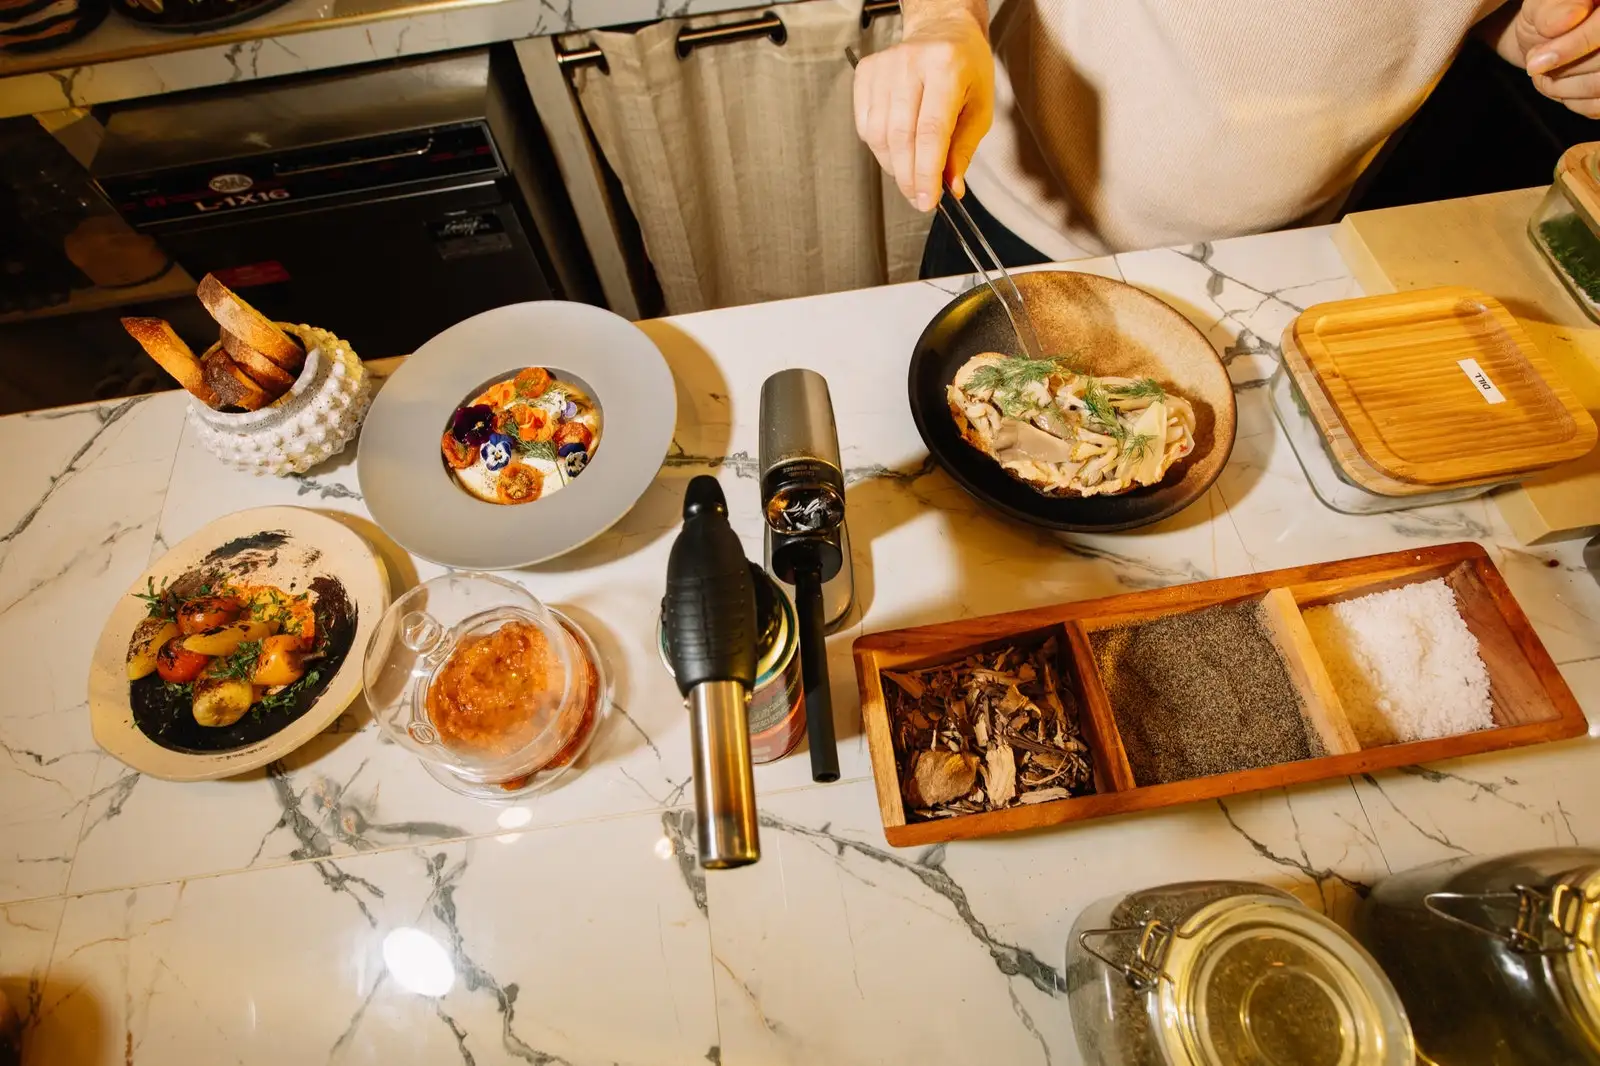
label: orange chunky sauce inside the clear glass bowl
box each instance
[427,621,566,755]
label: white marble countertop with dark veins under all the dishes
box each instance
[0,222,1600,1066]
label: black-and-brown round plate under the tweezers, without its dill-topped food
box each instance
[907,271,1237,533]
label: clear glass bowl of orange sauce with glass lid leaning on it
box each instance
[362,571,611,787]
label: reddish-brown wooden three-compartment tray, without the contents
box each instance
[854,543,1587,847]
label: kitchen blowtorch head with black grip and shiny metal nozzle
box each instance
[661,474,762,869]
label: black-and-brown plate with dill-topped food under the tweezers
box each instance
[907,271,1237,533]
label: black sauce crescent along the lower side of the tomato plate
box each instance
[128,573,357,755]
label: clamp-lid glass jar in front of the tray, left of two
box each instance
[1066,880,1413,1066]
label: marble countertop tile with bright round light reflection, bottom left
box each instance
[27,813,718,1066]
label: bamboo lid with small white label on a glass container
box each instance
[1282,287,1597,496]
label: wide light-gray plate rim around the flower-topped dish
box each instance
[357,301,677,570]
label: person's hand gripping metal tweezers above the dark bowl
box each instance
[856,5,995,211]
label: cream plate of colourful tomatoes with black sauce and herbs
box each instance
[90,507,389,781]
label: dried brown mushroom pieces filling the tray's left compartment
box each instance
[883,639,1094,820]
